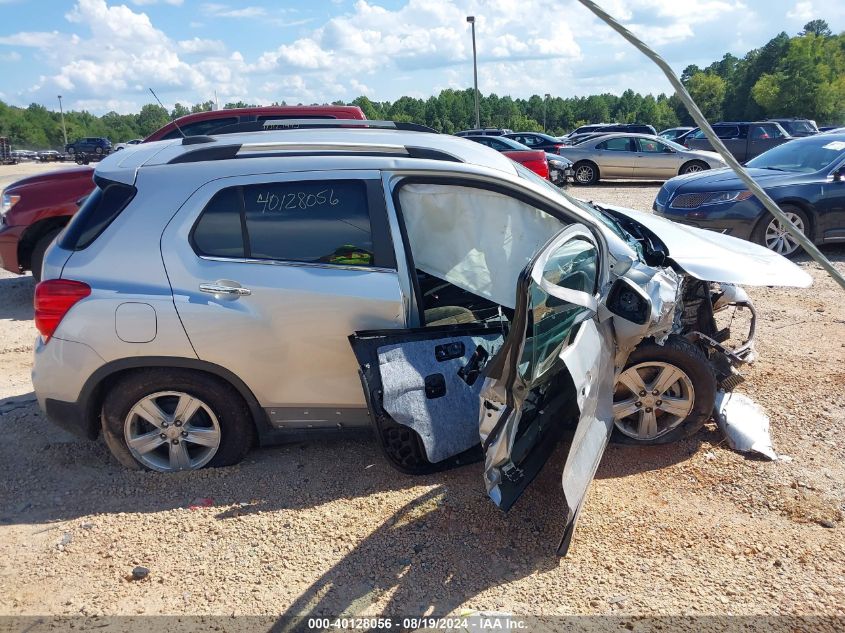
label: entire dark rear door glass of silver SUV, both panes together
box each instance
[191,180,380,266]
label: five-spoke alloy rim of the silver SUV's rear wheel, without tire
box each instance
[123,391,221,472]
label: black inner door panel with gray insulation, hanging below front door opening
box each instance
[349,324,505,474]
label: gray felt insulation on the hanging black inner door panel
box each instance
[378,334,503,463]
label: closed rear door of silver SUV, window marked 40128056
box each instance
[161,171,405,430]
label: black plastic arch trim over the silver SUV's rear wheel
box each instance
[78,356,272,439]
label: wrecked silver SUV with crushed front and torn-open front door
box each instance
[33,120,810,550]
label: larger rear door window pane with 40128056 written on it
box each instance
[243,180,374,266]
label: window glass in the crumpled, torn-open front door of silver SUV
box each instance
[520,238,598,380]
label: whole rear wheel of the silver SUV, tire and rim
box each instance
[101,368,256,472]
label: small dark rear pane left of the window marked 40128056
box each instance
[191,187,244,257]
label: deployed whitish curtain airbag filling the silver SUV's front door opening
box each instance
[399,184,565,308]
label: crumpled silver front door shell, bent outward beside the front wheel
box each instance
[480,225,614,554]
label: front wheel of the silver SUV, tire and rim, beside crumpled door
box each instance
[613,335,716,445]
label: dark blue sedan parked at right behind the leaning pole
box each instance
[654,134,845,256]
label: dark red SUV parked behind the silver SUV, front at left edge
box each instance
[0,106,367,281]
